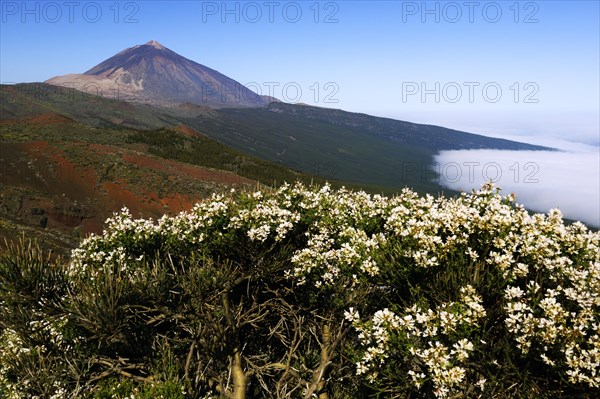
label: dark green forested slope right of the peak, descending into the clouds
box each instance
[182,103,549,193]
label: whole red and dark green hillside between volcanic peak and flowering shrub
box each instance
[0,83,564,253]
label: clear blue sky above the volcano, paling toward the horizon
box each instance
[0,0,600,144]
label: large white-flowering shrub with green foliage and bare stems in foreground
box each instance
[0,184,600,398]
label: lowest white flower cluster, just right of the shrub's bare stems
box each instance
[354,286,486,398]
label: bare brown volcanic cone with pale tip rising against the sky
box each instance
[46,40,272,108]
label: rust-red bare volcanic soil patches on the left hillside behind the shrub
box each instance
[0,132,256,244]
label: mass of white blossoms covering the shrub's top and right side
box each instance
[62,184,600,398]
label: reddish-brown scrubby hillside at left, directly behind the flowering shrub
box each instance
[0,111,326,253]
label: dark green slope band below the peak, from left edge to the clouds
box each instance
[0,84,549,193]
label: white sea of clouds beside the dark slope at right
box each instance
[434,139,600,227]
